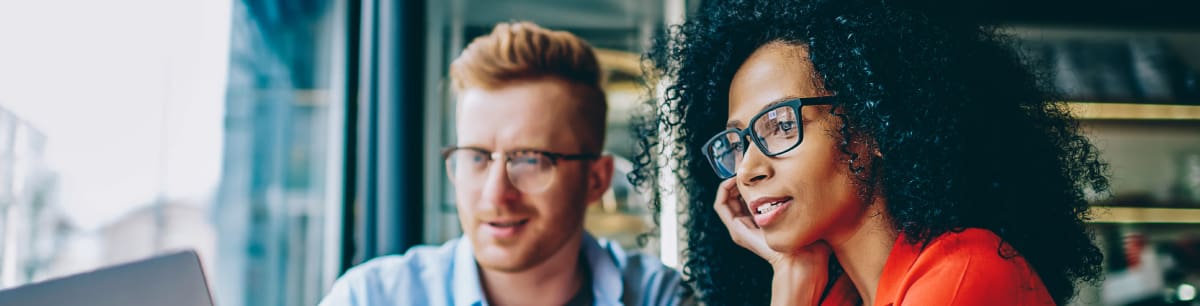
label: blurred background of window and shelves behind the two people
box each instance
[0,0,1200,306]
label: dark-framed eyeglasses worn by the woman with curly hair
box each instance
[703,96,833,180]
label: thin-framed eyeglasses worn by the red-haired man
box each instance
[442,146,600,193]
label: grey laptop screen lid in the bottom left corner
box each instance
[0,251,212,306]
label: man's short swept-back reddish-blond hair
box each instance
[450,22,608,152]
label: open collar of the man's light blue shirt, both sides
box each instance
[451,232,625,306]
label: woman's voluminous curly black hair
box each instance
[630,0,1109,305]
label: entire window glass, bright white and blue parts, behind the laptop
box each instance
[0,0,344,306]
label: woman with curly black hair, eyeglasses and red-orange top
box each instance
[632,0,1108,305]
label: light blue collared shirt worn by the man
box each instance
[320,233,690,306]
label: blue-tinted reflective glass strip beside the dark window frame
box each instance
[212,0,341,306]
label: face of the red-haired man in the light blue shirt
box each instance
[454,79,612,272]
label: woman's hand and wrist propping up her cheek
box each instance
[713,178,833,305]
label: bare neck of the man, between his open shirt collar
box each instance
[479,235,587,306]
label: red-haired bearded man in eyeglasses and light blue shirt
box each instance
[320,23,682,306]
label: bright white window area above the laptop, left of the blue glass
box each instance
[0,0,230,287]
